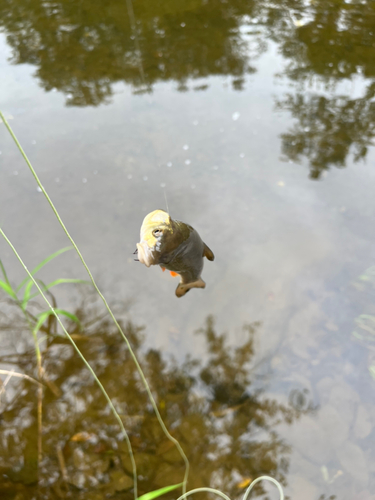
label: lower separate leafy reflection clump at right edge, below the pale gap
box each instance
[278,88,375,179]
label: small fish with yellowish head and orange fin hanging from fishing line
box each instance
[135,210,215,297]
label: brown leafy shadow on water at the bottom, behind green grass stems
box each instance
[0,292,314,500]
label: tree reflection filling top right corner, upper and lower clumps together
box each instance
[271,0,375,179]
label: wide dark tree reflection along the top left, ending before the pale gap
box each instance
[0,0,262,106]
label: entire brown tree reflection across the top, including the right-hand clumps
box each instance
[0,0,375,179]
